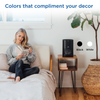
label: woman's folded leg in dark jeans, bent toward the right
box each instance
[23,64,40,78]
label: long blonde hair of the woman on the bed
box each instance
[14,28,30,49]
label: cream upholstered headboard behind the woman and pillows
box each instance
[0,45,50,70]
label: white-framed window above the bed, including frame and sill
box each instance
[0,9,51,29]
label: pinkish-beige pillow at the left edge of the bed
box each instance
[0,53,10,71]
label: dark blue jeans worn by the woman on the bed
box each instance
[9,59,39,79]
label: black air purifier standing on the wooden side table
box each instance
[62,39,73,57]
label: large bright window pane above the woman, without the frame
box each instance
[7,9,45,22]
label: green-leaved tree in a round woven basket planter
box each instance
[67,12,100,95]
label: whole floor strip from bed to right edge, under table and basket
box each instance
[55,88,100,100]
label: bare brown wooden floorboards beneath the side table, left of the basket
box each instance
[56,88,85,100]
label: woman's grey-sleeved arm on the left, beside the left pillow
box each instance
[6,46,17,65]
